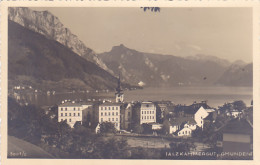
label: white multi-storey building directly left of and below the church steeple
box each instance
[98,103,122,130]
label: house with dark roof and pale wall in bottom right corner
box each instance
[220,118,253,156]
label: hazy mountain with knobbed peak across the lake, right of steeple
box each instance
[99,44,250,87]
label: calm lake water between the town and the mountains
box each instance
[15,87,253,108]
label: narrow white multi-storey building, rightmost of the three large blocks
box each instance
[140,102,156,124]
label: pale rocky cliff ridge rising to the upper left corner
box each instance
[8,7,111,72]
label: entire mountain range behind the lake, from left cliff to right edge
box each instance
[8,7,253,89]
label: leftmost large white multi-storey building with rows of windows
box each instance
[58,101,92,128]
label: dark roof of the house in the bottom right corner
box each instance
[223,119,253,135]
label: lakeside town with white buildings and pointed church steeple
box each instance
[50,77,253,158]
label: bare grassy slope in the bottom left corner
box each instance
[7,136,53,158]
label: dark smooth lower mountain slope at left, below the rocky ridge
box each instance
[8,21,132,90]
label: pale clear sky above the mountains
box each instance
[32,7,253,62]
